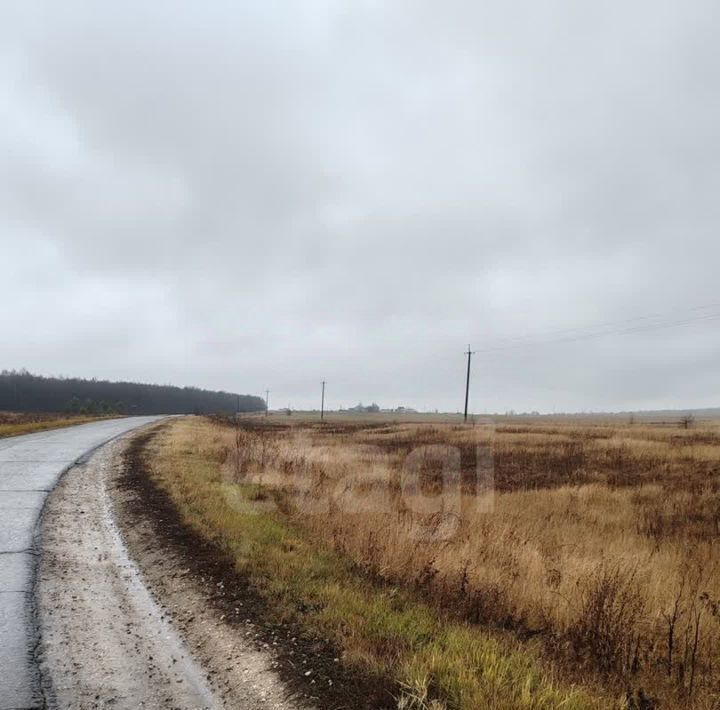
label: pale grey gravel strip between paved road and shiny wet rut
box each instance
[35,436,222,710]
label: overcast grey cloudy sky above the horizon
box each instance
[0,0,720,411]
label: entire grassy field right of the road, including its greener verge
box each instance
[143,417,720,708]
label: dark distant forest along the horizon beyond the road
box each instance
[0,370,265,414]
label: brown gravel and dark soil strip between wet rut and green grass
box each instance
[118,428,396,710]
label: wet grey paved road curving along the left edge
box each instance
[0,417,159,710]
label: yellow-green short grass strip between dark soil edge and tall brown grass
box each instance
[143,419,609,710]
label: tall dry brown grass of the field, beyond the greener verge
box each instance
[211,419,720,708]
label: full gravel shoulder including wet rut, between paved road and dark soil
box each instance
[35,437,307,710]
